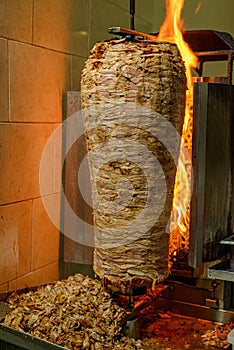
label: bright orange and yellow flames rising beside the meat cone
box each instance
[158,0,197,264]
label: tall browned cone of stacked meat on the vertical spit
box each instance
[81,39,186,294]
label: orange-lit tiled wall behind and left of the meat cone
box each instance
[0,0,157,292]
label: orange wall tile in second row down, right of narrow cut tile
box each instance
[9,40,71,123]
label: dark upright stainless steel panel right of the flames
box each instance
[189,83,234,267]
